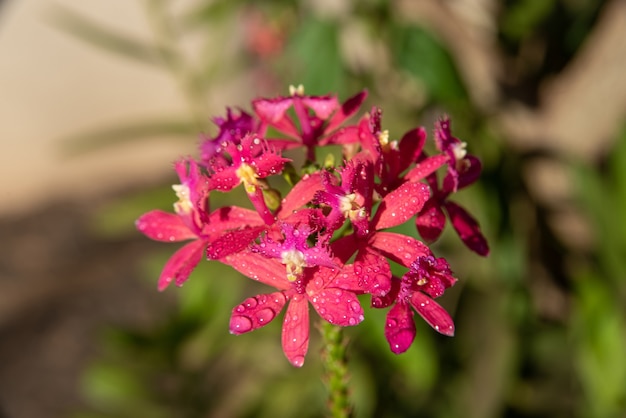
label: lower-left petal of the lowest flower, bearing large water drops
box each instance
[229,292,287,335]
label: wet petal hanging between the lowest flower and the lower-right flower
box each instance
[354,250,391,296]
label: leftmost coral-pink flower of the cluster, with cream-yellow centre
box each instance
[135,160,260,290]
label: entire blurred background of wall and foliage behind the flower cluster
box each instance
[0,0,626,418]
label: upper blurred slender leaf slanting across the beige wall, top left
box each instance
[49,5,173,66]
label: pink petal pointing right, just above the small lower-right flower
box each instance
[369,231,432,267]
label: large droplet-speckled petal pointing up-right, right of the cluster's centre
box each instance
[373,183,430,230]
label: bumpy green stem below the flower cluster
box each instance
[320,320,352,418]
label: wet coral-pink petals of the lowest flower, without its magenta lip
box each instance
[224,251,363,367]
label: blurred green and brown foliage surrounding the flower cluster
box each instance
[54,0,626,418]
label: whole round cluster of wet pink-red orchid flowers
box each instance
[136,87,489,366]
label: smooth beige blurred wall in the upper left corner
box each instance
[0,0,199,215]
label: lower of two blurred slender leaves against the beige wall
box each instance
[61,118,201,156]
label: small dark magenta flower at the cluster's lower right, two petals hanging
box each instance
[372,256,456,354]
